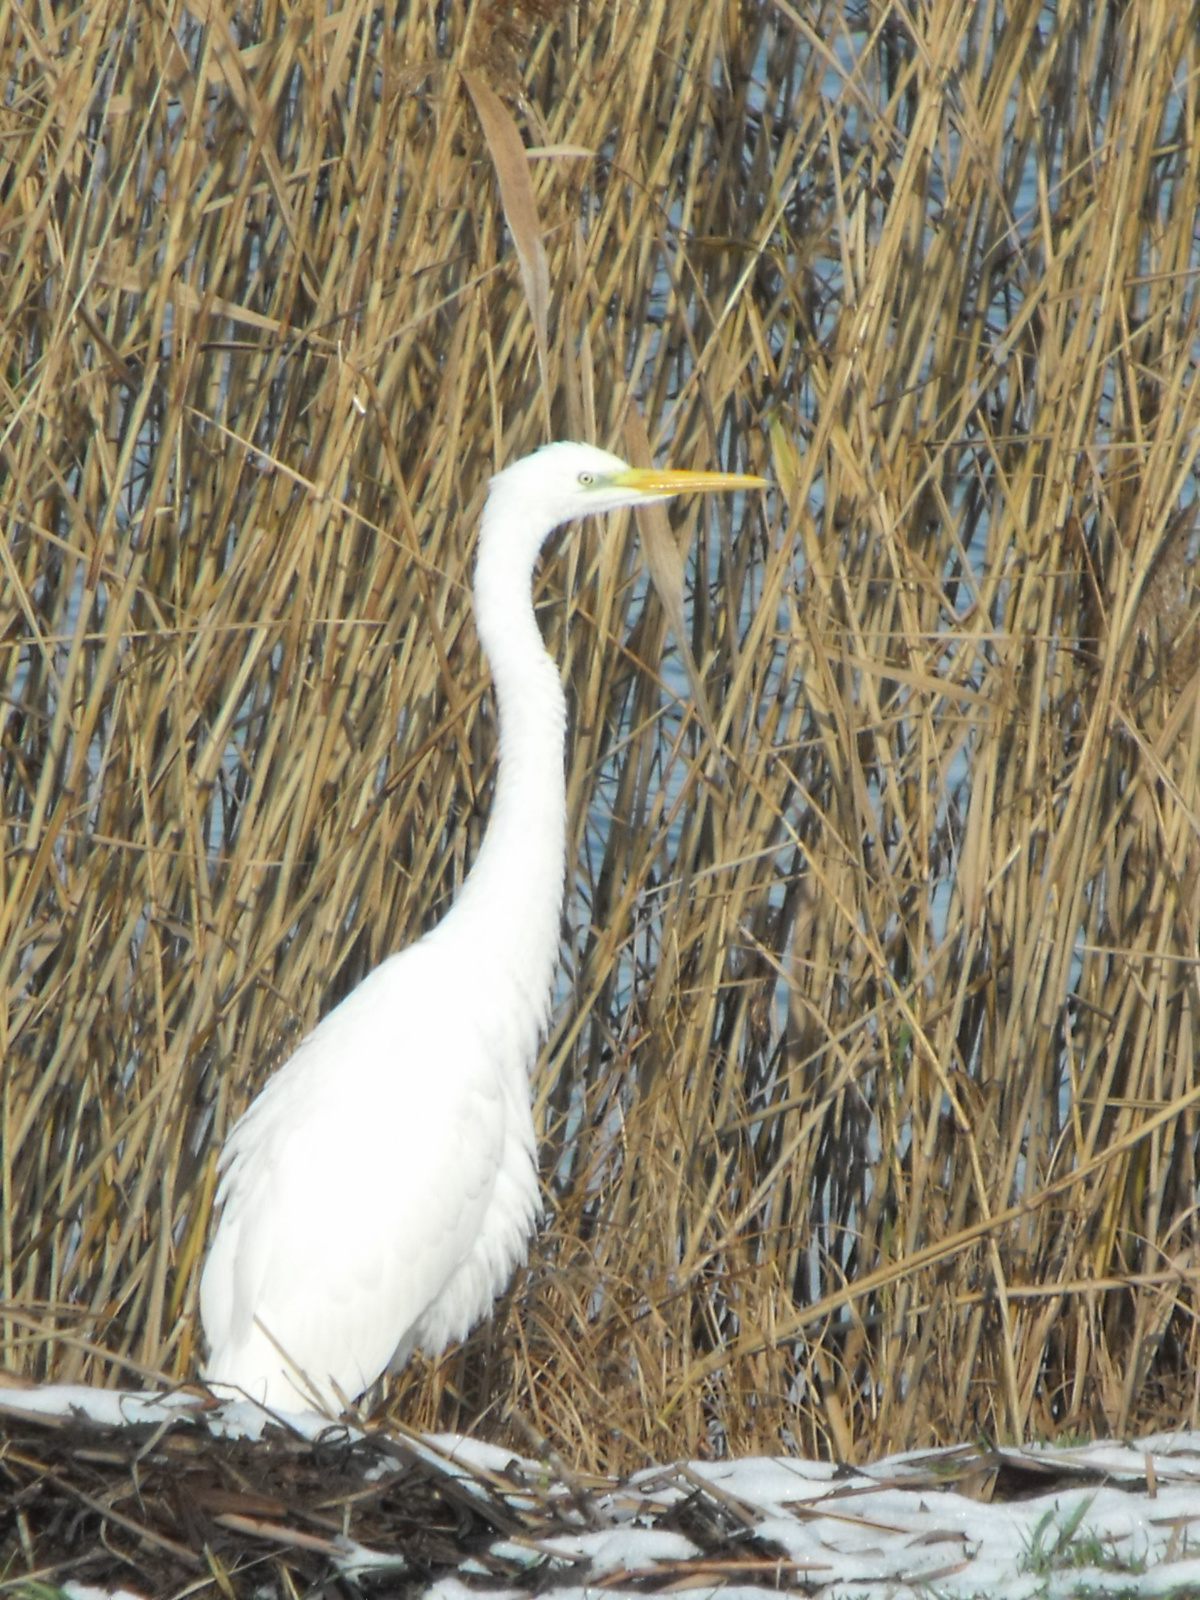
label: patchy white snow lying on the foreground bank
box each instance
[0,1387,1200,1600]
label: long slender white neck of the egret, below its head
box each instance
[451,499,566,1029]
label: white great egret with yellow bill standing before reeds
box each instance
[200,443,763,1414]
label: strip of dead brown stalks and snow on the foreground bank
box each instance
[0,1395,1195,1600]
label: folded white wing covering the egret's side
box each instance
[202,946,507,1395]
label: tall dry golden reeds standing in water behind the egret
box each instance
[0,0,1200,1469]
